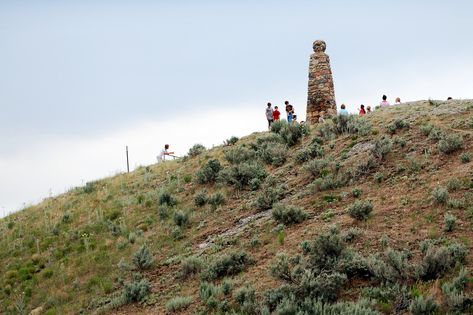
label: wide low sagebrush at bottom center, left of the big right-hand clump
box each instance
[202,251,253,281]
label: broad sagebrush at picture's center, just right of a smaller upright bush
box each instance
[220,163,267,190]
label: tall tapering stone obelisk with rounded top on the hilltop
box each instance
[307,40,337,124]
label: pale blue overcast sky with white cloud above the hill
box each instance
[0,0,473,216]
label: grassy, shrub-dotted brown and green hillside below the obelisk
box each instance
[0,101,473,314]
